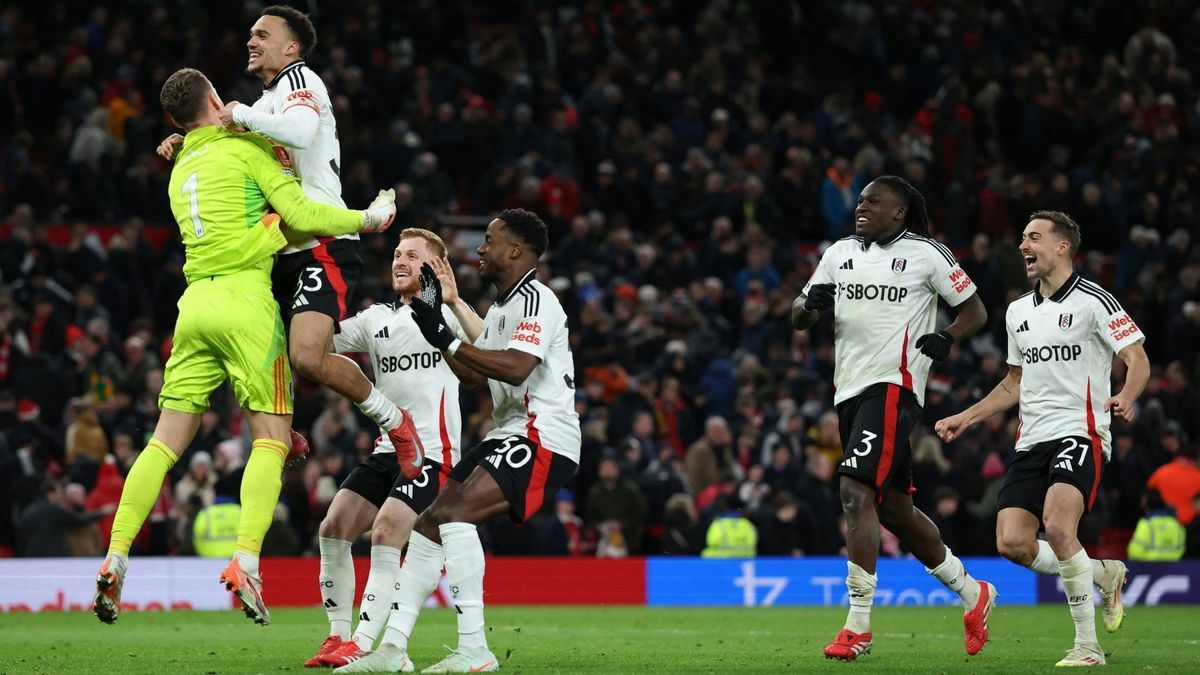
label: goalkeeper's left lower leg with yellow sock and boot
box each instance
[92,408,200,623]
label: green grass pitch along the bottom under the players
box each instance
[0,604,1200,675]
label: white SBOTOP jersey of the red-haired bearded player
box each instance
[334,301,467,466]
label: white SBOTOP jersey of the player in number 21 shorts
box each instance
[1004,274,1145,459]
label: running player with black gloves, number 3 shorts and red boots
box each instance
[792,175,996,661]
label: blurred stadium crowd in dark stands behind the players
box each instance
[0,0,1200,557]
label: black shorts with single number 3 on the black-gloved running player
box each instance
[838,382,920,492]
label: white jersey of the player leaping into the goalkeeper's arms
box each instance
[251,61,359,256]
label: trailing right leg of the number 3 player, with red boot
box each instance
[880,489,997,656]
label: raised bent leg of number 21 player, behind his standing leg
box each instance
[996,507,1128,633]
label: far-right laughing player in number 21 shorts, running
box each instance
[935,211,1150,665]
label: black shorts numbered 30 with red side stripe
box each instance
[450,435,580,522]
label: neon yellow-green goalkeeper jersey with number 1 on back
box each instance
[168,126,362,283]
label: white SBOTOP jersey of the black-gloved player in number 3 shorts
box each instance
[804,229,976,405]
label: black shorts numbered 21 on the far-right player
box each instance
[996,436,1104,518]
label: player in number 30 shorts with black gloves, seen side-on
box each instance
[335,209,581,673]
